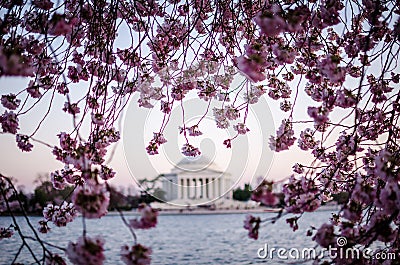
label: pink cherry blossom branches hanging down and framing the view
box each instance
[0,0,400,264]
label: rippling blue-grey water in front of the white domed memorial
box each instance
[0,211,330,265]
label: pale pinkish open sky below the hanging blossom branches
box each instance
[0,72,316,191]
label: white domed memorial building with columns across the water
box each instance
[162,157,233,201]
